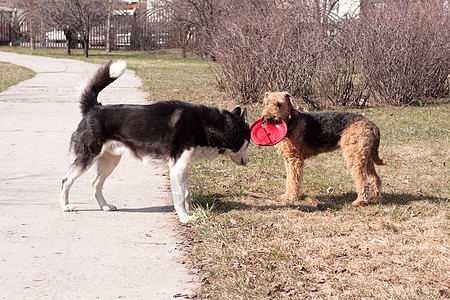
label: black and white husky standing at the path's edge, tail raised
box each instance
[60,61,250,223]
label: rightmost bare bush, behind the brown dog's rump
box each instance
[352,1,450,105]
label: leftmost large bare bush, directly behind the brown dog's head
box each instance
[211,1,322,103]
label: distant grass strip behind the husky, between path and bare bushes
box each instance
[0,47,227,105]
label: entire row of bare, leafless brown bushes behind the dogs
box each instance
[207,0,450,107]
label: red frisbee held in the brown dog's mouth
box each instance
[250,119,287,146]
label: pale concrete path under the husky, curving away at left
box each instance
[0,52,199,299]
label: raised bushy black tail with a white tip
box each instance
[80,60,126,116]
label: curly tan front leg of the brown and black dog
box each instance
[280,157,304,201]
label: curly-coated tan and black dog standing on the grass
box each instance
[262,92,386,207]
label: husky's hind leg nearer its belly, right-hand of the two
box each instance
[90,152,122,211]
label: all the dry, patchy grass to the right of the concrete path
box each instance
[0,48,450,299]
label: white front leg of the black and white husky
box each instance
[169,159,192,223]
